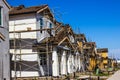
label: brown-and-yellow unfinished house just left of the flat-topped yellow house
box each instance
[83,42,97,71]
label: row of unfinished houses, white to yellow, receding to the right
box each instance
[0,0,114,80]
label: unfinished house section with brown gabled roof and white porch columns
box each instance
[34,25,81,76]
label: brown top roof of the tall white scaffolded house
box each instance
[9,5,48,15]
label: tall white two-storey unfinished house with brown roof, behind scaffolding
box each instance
[9,5,54,77]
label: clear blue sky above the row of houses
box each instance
[7,0,120,58]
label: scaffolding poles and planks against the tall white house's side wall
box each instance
[9,28,54,80]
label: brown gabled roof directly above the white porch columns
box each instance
[33,25,74,49]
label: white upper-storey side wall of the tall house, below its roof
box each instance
[9,14,37,39]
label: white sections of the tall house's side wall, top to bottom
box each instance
[9,14,39,77]
